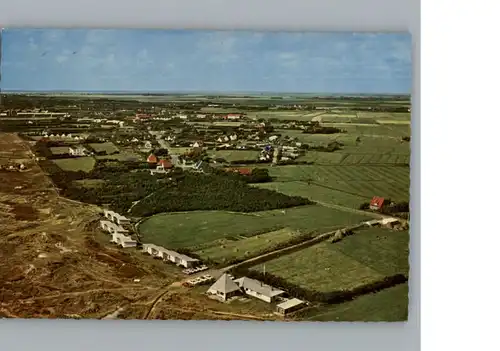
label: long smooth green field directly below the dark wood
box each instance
[139,205,367,249]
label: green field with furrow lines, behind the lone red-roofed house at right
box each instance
[262,165,410,207]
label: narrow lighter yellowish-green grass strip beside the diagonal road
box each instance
[195,228,298,262]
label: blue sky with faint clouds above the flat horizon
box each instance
[0,29,412,94]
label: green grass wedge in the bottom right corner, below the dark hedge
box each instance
[302,284,409,322]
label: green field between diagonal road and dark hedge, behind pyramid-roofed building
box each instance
[252,228,409,292]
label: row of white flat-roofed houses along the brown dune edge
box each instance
[101,210,203,269]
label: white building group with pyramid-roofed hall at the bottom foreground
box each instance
[207,273,307,316]
